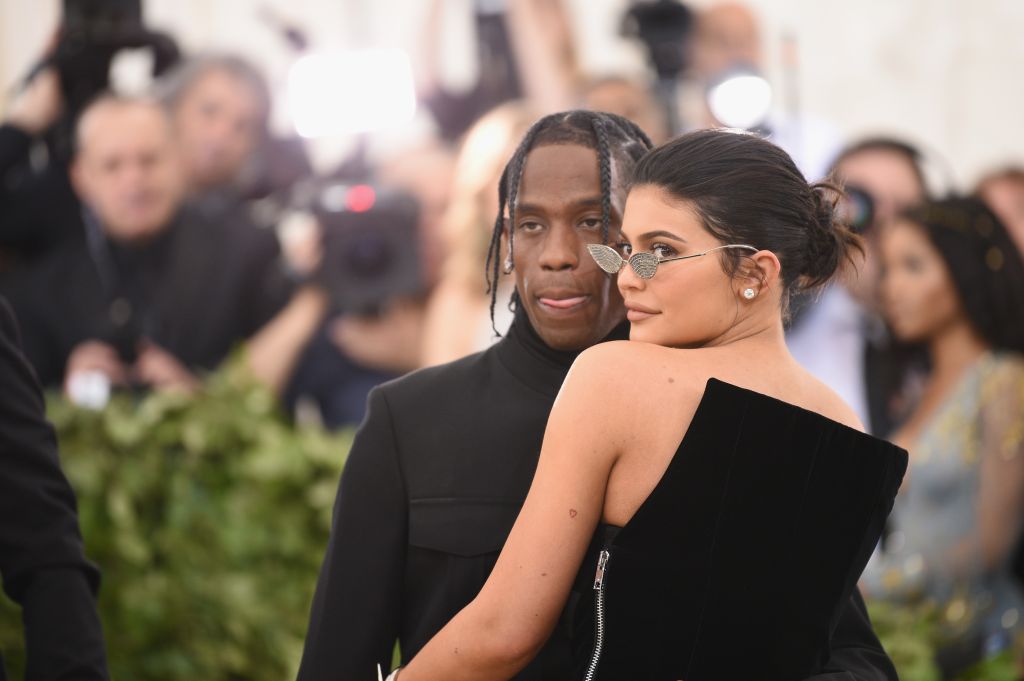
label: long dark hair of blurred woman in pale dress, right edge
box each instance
[903,198,1024,352]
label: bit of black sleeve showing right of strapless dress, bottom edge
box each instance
[808,589,899,681]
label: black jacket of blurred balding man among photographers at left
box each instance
[3,201,289,386]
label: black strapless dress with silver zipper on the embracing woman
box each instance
[569,379,907,681]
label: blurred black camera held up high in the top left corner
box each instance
[30,0,180,156]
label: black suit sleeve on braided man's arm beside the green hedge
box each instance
[299,388,409,681]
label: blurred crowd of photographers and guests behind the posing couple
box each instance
[0,0,1024,669]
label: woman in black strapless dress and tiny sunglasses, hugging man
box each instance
[389,131,906,681]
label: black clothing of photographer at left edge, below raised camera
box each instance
[0,124,82,269]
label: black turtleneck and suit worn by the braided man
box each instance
[299,313,896,681]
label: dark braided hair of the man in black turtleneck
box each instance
[485,110,652,327]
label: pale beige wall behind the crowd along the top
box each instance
[0,0,1024,182]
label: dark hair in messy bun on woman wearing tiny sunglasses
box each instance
[632,130,861,310]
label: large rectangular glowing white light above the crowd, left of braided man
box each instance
[288,49,416,137]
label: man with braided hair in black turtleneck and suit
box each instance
[299,112,896,681]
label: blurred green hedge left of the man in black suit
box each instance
[0,370,350,681]
